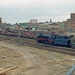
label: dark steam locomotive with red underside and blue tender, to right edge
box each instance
[37,33,75,47]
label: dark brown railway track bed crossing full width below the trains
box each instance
[0,35,75,56]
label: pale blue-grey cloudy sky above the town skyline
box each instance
[0,0,75,24]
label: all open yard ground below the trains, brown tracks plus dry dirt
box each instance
[0,35,75,75]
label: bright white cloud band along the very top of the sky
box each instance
[0,0,75,6]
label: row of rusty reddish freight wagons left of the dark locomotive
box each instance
[0,30,37,39]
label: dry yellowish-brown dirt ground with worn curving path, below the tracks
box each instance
[0,41,75,75]
